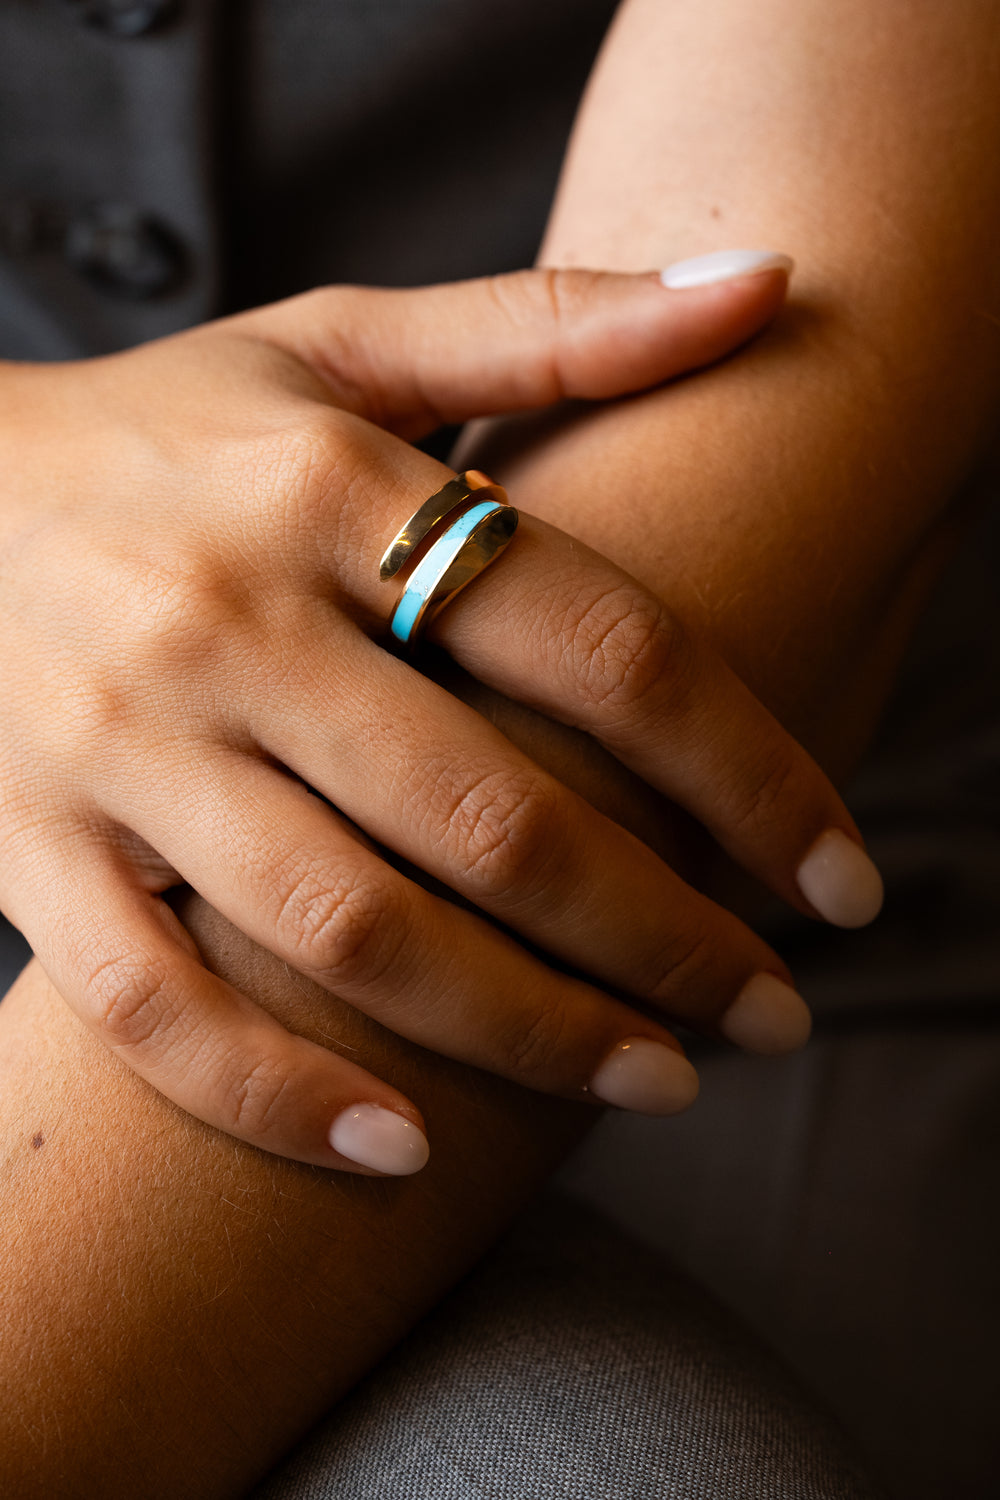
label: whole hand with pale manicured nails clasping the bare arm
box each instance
[0,261,874,1172]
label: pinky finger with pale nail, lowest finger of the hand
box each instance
[16,861,429,1176]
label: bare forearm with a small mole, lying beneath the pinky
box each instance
[0,908,589,1500]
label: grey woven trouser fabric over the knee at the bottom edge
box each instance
[253,1200,876,1500]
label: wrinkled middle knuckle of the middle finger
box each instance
[442,773,564,900]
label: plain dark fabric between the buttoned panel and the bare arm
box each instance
[226,0,616,303]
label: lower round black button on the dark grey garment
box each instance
[64,203,186,300]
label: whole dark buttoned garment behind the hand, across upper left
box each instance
[0,0,615,359]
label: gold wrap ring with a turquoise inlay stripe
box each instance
[385,470,517,645]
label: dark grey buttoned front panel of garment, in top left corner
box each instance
[0,0,222,359]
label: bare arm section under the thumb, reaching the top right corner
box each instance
[467,0,1000,770]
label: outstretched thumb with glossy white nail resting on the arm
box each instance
[241,251,792,440]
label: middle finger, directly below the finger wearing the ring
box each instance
[253,618,805,1052]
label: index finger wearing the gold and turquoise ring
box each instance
[319,429,882,927]
